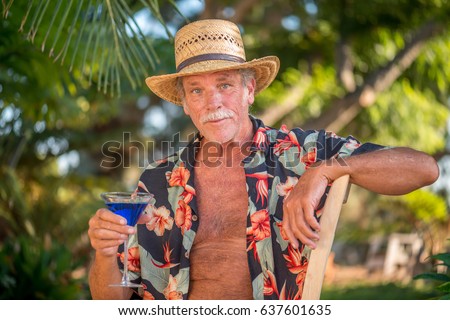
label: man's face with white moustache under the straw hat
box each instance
[182,70,255,143]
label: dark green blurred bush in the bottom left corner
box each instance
[0,236,87,300]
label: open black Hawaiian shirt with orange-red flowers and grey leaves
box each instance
[118,116,382,299]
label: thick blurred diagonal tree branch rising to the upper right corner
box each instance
[303,22,444,132]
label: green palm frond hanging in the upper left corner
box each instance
[2,0,183,95]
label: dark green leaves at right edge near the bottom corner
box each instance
[414,252,450,300]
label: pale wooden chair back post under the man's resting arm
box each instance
[302,175,350,300]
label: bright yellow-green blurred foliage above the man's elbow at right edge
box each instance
[354,79,449,154]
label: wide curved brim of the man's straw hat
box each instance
[145,56,280,106]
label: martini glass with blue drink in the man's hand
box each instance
[101,192,153,288]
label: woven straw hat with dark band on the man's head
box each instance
[145,19,280,106]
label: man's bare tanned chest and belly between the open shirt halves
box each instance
[189,162,252,299]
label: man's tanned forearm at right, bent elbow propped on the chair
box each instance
[326,147,439,195]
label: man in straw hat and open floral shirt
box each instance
[89,20,439,299]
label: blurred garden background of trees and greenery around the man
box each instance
[0,0,450,299]
